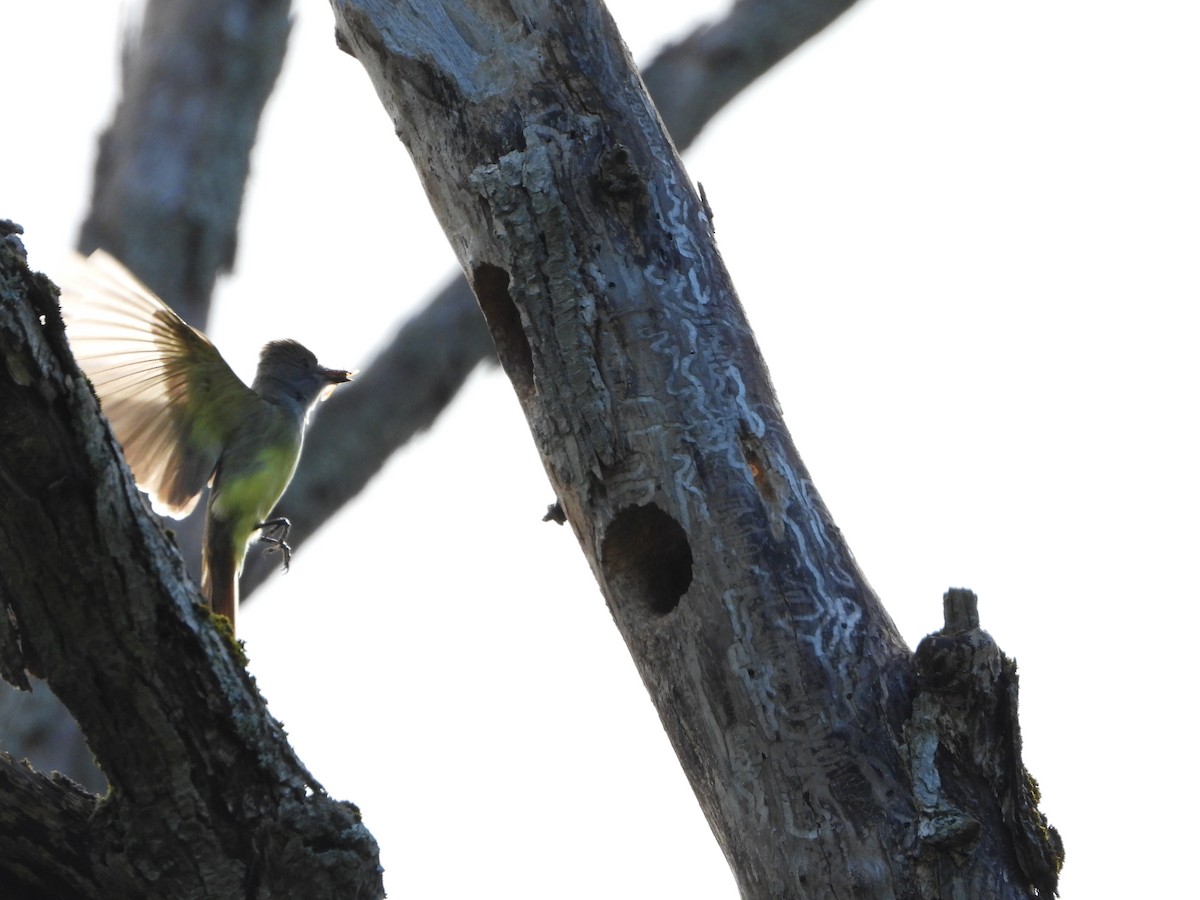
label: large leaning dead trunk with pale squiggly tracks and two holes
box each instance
[334,0,1046,898]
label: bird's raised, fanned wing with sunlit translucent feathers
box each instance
[61,251,257,518]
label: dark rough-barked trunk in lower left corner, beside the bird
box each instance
[0,229,383,899]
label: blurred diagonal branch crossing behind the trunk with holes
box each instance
[241,0,853,592]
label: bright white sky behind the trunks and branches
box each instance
[0,0,1200,900]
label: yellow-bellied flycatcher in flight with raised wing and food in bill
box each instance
[61,250,352,638]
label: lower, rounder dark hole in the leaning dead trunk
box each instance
[601,503,692,616]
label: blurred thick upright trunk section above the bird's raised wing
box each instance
[79,0,292,329]
